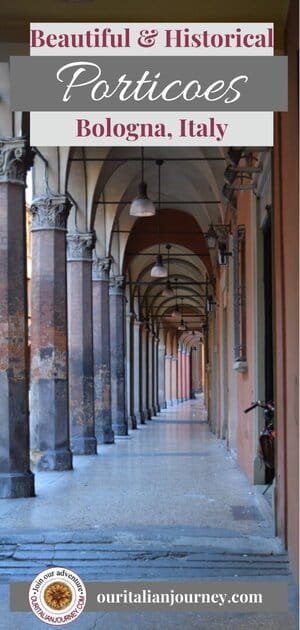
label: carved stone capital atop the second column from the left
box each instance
[31,195,72,232]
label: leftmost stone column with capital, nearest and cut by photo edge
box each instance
[0,138,34,499]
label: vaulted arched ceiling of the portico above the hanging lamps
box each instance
[65,147,227,334]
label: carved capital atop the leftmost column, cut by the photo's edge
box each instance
[0,138,27,186]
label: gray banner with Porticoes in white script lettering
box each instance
[10,56,287,112]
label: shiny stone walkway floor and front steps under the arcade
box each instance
[0,400,298,630]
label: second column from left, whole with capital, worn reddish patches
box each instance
[30,195,72,470]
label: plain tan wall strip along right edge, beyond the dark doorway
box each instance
[274,0,299,577]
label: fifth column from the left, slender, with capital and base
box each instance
[109,276,128,435]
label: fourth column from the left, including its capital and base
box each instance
[92,252,114,444]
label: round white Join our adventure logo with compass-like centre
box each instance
[29,567,86,626]
